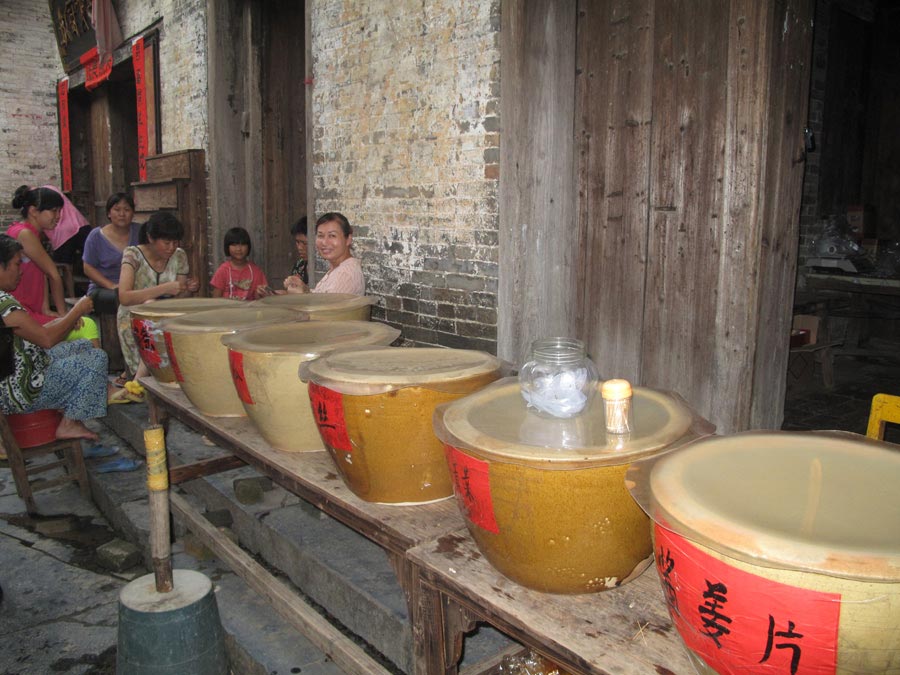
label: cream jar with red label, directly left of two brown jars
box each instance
[222,321,400,452]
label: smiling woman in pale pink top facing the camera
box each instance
[284,213,366,295]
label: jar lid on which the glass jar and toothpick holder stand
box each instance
[435,378,714,469]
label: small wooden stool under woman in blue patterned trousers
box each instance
[0,413,91,513]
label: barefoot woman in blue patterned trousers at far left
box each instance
[0,234,109,440]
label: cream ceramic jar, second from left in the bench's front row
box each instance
[160,304,303,417]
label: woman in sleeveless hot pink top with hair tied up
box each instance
[6,185,99,340]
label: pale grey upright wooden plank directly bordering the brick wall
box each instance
[497,0,580,362]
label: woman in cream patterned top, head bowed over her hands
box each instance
[116,211,200,378]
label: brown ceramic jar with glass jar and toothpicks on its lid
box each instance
[434,378,713,593]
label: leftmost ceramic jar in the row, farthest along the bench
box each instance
[131,298,240,387]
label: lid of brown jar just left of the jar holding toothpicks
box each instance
[308,347,501,395]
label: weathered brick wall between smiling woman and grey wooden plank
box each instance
[312,0,500,352]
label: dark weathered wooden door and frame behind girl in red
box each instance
[208,0,307,285]
